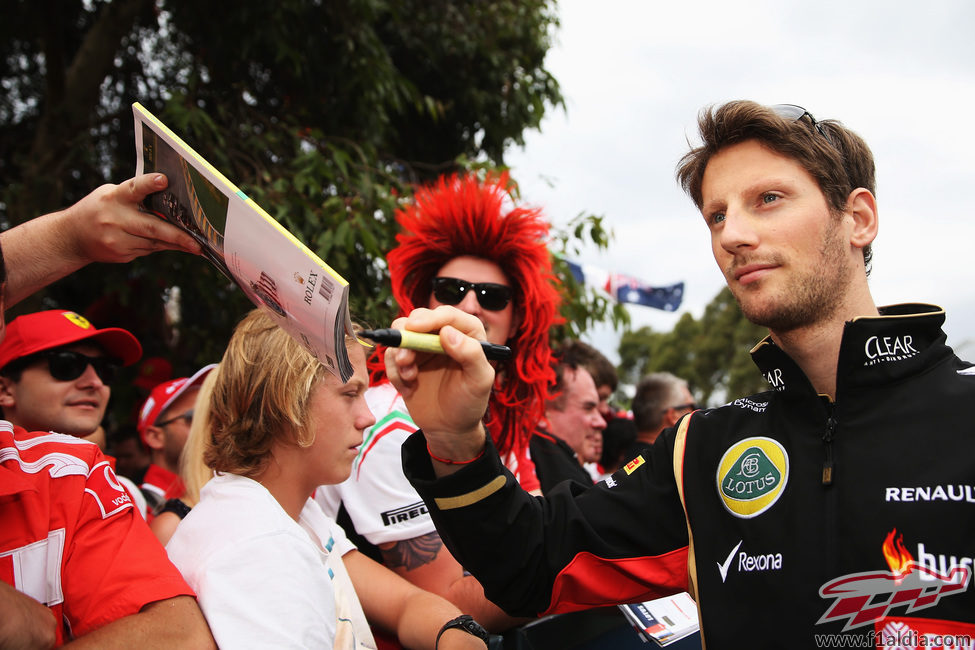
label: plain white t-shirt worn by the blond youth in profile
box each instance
[166,474,376,650]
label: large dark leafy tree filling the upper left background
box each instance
[0,0,618,428]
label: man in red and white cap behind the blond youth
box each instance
[137,363,217,509]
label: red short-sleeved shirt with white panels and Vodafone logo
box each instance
[0,420,195,645]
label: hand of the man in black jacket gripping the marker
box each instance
[386,306,494,461]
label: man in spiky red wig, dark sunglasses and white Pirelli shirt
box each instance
[317,173,559,631]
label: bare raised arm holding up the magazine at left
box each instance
[0,174,200,307]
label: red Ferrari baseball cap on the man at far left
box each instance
[0,309,142,368]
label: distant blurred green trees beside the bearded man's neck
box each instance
[619,288,768,404]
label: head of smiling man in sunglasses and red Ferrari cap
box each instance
[0,309,142,436]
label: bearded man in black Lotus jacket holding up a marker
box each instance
[387,102,975,648]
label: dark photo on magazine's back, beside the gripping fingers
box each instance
[142,125,233,280]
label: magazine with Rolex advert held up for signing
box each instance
[132,103,352,381]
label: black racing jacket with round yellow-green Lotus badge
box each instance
[403,305,975,648]
